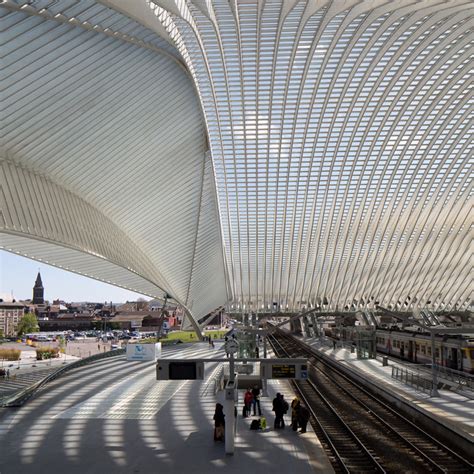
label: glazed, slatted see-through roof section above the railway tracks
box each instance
[150,1,474,311]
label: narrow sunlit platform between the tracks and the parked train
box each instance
[301,337,474,443]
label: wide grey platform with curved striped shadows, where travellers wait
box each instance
[0,343,332,474]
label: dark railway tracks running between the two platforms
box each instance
[270,330,474,473]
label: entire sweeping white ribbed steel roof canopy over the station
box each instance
[0,0,474,318]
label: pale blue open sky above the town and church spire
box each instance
[0,250,150,303]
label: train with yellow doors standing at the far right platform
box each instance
[326,327,474,374]
